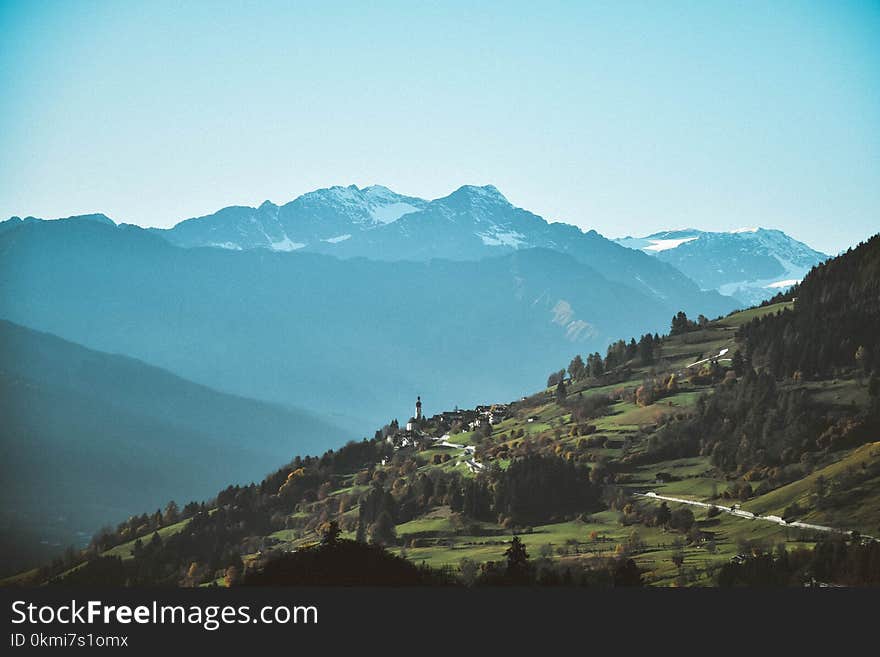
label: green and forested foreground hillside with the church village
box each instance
[17,237,880,586]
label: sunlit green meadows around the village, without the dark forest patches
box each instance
[10,264,880,586]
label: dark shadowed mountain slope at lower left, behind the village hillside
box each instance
[0,320,344,568]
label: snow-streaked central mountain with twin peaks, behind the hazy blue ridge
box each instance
[156,185,735,316]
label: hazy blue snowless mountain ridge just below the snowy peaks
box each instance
[0,214,700,430]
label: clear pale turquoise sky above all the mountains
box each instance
[0,0,880,253]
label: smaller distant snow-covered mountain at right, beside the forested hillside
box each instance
[615,228,828,305]
